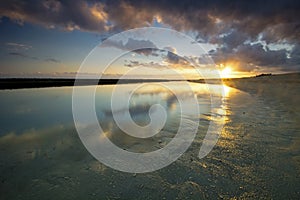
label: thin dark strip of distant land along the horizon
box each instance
[0,73,300,90]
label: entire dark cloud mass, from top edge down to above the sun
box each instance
[0,0,300,70]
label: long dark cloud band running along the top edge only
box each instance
[0,0,300,40]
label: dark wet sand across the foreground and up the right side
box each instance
[0,75,300,199]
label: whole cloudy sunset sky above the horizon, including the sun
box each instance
[0,0,300,77]
